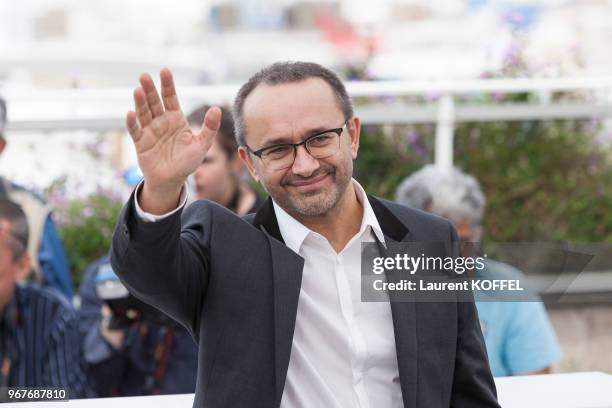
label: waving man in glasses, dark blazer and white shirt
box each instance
[111,62,498,408]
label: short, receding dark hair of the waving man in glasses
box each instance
[232,61,353,146]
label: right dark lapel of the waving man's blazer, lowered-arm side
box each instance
[368,196,418,408]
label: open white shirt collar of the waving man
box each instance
[272,179,385,253]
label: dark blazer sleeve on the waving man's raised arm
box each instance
[110,193,212,341]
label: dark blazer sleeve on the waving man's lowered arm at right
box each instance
[450,225,499,408]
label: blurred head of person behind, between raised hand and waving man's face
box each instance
[187,105,263,215]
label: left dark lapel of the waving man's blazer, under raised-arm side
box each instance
[253,198,304,406]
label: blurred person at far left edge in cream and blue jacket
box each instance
[0,98,72,300]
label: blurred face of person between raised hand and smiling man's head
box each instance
[193,141,242,205]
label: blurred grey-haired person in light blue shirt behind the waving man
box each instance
[396,165,561,377]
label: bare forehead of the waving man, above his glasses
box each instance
[243,78,343,143]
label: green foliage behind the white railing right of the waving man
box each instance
[356,37,612,242]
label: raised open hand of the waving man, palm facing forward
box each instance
[126,68,221,214]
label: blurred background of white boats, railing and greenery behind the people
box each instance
[0,0,612,378]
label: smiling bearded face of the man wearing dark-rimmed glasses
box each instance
[240,78,359,216]
